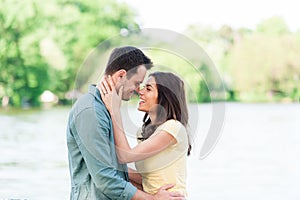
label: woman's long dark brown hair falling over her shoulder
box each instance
[142,72,191,155]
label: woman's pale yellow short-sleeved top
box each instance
[135,120,188,197]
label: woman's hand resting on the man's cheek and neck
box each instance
[97,76,123,114]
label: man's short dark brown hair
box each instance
[105,46,152,77]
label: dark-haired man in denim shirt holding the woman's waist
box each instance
[67,46,182,200]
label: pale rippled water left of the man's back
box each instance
[0,109,69,199]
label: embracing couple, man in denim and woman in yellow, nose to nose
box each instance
[67,46,191,200]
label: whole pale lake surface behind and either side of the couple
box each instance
[0,103,300,200]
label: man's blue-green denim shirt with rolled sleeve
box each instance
[67,85,137,200]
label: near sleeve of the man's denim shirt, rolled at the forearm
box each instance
[75,109,137,200]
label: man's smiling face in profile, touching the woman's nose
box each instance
[122,65,147,101]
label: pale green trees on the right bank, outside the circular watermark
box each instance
[187,16,300,101]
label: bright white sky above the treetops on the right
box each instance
[120,0,300,32]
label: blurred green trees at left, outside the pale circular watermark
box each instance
[0,0,138,107]
